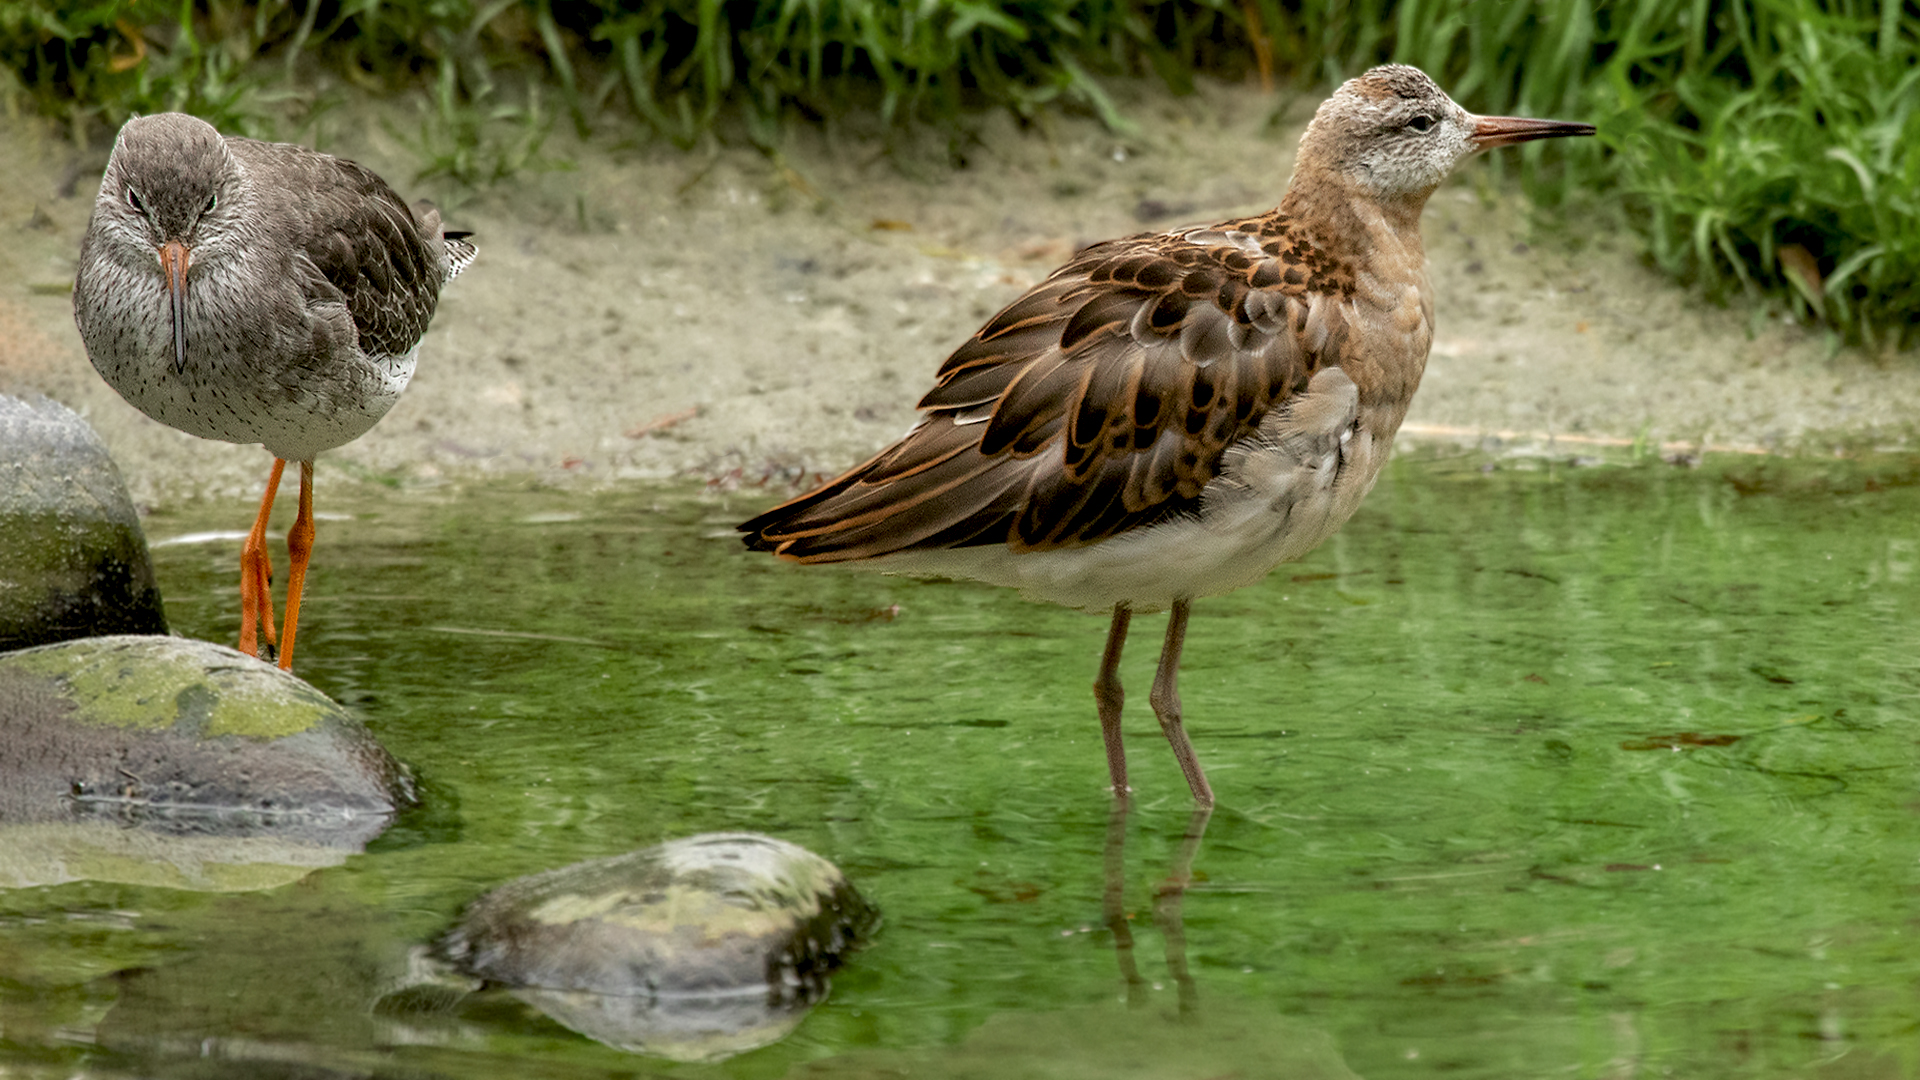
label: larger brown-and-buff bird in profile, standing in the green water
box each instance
[739,63,1594,805]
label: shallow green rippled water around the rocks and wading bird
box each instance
[0,449,1920,1080]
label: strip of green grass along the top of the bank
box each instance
[0,0,1920,348]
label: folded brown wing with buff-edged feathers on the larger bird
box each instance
[739,211,1346,561]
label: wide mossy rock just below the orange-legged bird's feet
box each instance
[0,636,415,888]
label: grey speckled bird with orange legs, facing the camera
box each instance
[73,113,474,669]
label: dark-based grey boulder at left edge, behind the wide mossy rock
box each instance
[0,394,167,651]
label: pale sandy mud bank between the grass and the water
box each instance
[0,85,1920,505]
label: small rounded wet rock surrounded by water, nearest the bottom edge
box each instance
[442,832,877,1061]
